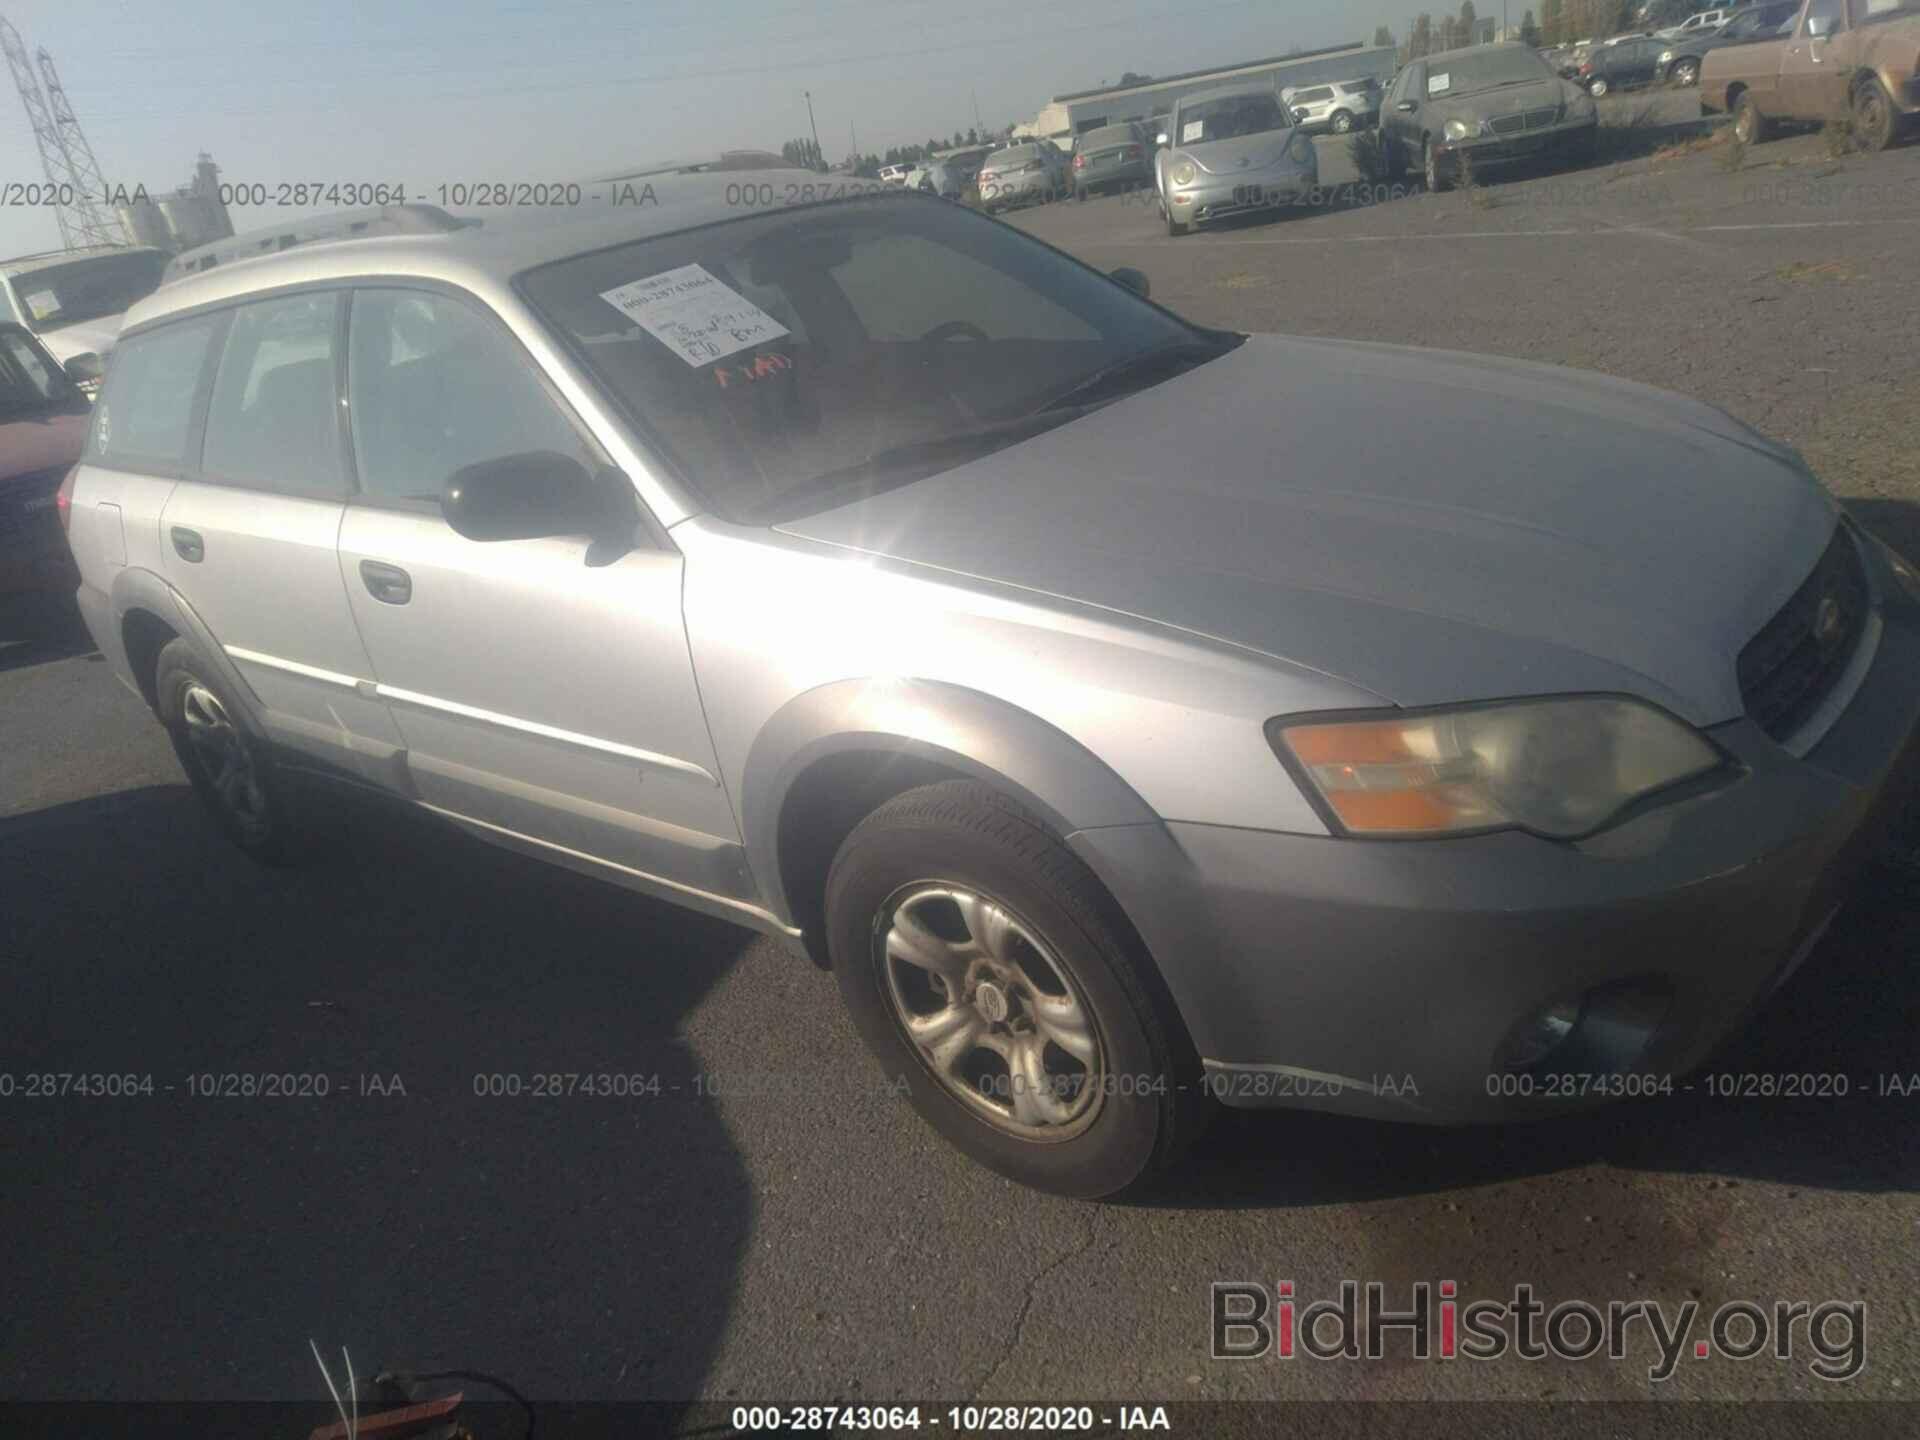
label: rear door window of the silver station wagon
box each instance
[202,294,346,495]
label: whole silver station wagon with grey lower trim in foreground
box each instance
[60,186,1920,1196]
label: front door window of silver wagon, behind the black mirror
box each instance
[348,290,595,501]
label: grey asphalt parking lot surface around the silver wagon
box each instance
[0,92,1920,1432]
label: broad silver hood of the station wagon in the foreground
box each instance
[781,336,1837,724]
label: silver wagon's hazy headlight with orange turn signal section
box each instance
[1267,697,1722,839]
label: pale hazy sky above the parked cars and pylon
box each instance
[0,0,1382,255]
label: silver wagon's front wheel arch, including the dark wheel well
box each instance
[739,680,1158,962]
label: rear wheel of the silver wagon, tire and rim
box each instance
[154,639,313,866]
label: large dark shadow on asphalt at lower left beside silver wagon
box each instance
[0,785,753,1402]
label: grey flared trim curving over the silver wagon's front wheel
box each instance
[739,680,1158,922]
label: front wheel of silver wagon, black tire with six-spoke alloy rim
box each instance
[826,780,1212,1200]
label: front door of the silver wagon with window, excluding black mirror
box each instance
[340,288,753,900]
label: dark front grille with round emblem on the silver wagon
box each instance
[1738,526,1872,741]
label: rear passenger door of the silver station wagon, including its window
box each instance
[153,290,399,785]
